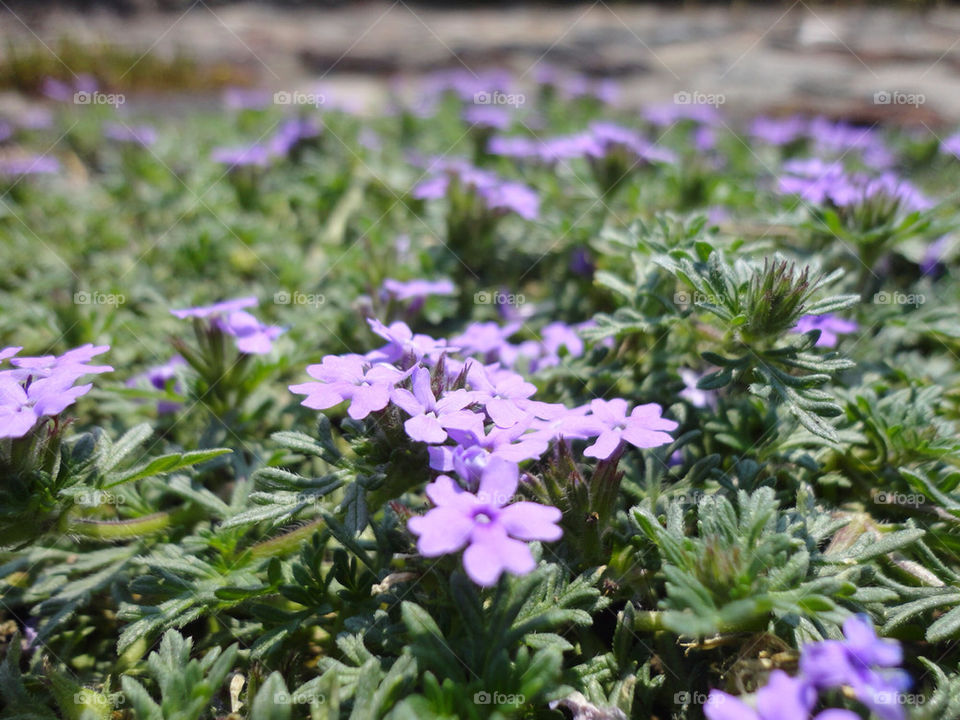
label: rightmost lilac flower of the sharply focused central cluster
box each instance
[583,398,678,460]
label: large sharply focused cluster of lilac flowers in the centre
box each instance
[290,320,677,586]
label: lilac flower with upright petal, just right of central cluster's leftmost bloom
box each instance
[390,367,483,444]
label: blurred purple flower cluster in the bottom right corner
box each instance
[705,616,910,720]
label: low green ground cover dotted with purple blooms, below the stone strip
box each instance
[0,64,960,720]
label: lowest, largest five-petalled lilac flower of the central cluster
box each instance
[407,458,563,587]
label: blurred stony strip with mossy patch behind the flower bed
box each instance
[0,0,960,128]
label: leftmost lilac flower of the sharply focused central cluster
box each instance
[290,355,404,420]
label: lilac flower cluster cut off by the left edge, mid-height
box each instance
[0,345,113,438]
